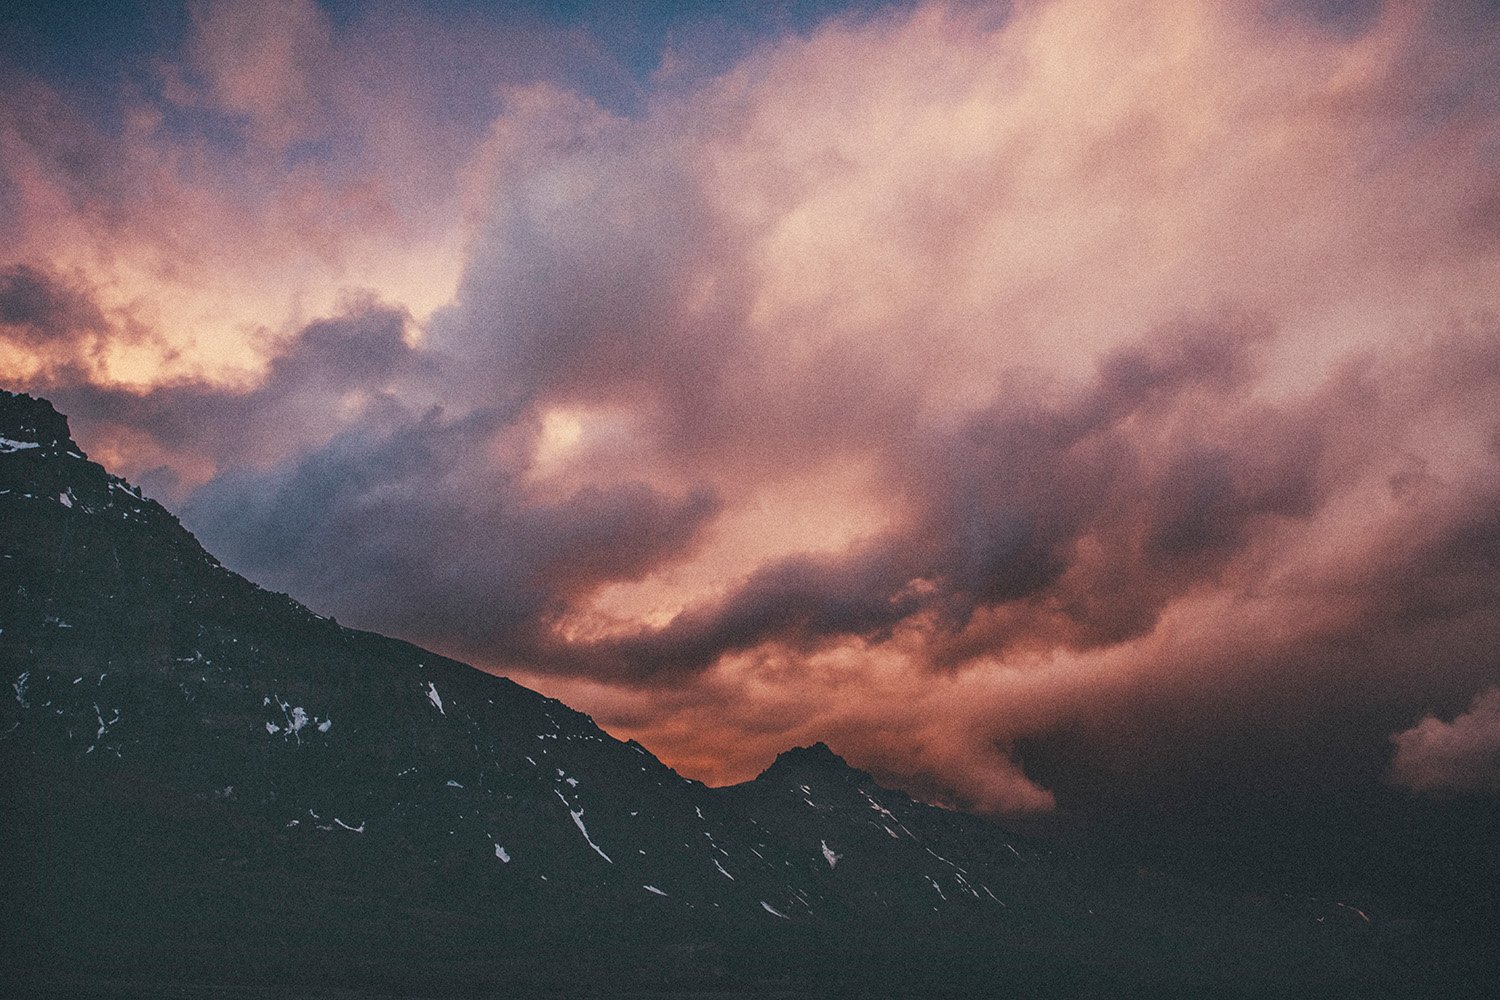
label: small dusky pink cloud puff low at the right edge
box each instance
[1391,688,1500,793]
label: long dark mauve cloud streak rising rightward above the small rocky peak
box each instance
[539,318,1320,682]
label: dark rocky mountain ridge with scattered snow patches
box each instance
[0,393,1472,997]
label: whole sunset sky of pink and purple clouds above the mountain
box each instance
[0,0,1500,875]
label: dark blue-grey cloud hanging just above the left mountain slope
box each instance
[185,409,719,657]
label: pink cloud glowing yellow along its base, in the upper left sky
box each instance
[0,0,639,385]
